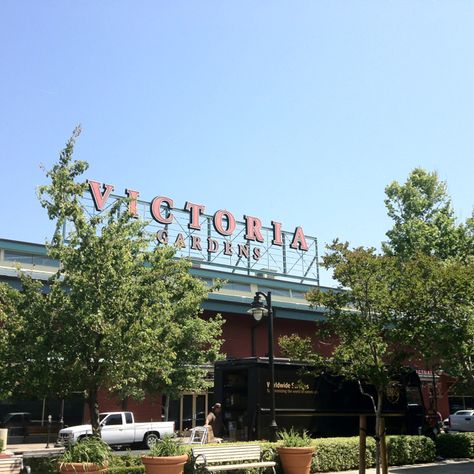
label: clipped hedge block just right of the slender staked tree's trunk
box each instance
[387,436,436,466]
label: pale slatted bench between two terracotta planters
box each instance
[191,444,276,474]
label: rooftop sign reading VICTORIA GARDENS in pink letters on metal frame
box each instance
[88,180,319,282]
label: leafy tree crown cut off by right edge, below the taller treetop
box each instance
[394,254,474,387]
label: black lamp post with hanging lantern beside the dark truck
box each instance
[248,291,278,441]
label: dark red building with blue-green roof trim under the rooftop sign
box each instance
[0,233,468,436]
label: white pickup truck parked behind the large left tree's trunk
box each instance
[57,411,174,448]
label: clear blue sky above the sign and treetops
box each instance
[0,0,474,283]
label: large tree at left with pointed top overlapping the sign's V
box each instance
[25,128,222,432]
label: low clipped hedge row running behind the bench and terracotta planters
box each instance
[20,434,440,474]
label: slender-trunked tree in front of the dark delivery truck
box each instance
[307,240,408,470]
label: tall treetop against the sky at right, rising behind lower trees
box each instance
[383,168,474,259]
